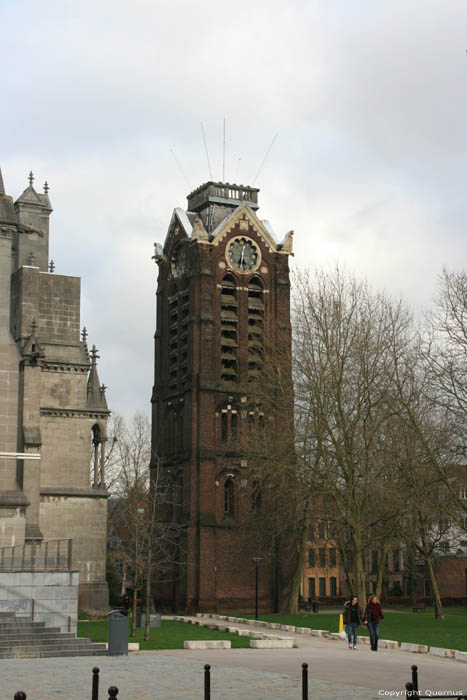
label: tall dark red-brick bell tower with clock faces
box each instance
[152,182,293,611]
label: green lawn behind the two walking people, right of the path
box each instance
[245,609,467,651]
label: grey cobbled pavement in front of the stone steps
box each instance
[0,651,377,700]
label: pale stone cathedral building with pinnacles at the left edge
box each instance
[0,168,109,609]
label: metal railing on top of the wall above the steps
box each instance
[0,539,72,571]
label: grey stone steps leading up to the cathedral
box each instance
[0,613,107,659]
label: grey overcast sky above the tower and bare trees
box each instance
[0,0,467,415]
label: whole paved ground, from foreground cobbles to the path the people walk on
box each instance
[0,624,467,700]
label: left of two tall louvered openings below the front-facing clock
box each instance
[221,275,238,384]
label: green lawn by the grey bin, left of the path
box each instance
[78,620,250,650]
